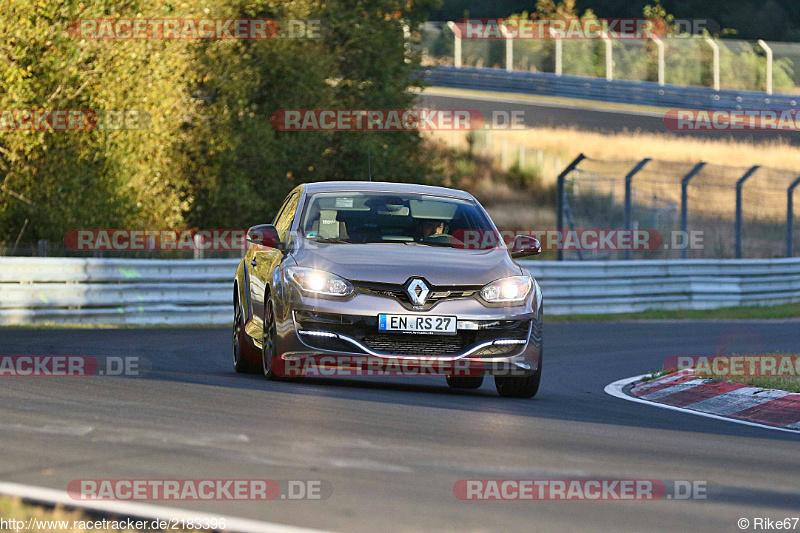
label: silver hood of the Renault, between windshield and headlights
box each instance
[293,243,522,285]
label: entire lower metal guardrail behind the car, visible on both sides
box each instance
[0,258,800,325]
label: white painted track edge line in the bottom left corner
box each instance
[0,481,326,533]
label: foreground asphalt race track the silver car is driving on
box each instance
[0,321,800,532]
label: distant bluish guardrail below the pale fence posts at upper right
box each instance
[422,66,800,109]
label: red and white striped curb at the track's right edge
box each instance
[605,369,800,434]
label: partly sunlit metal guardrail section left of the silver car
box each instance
[0,257,239,325]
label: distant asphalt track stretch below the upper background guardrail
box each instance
[418,88,800,145]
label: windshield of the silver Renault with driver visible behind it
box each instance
[299,192,494,248]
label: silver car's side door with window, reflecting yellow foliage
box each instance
[245,189,301,322]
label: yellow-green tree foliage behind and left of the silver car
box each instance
[0,0,438,243]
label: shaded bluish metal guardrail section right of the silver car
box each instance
[523,258,800,315]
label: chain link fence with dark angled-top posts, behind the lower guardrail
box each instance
[558,156,800,260]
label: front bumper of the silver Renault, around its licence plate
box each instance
[276,289,542,376]
